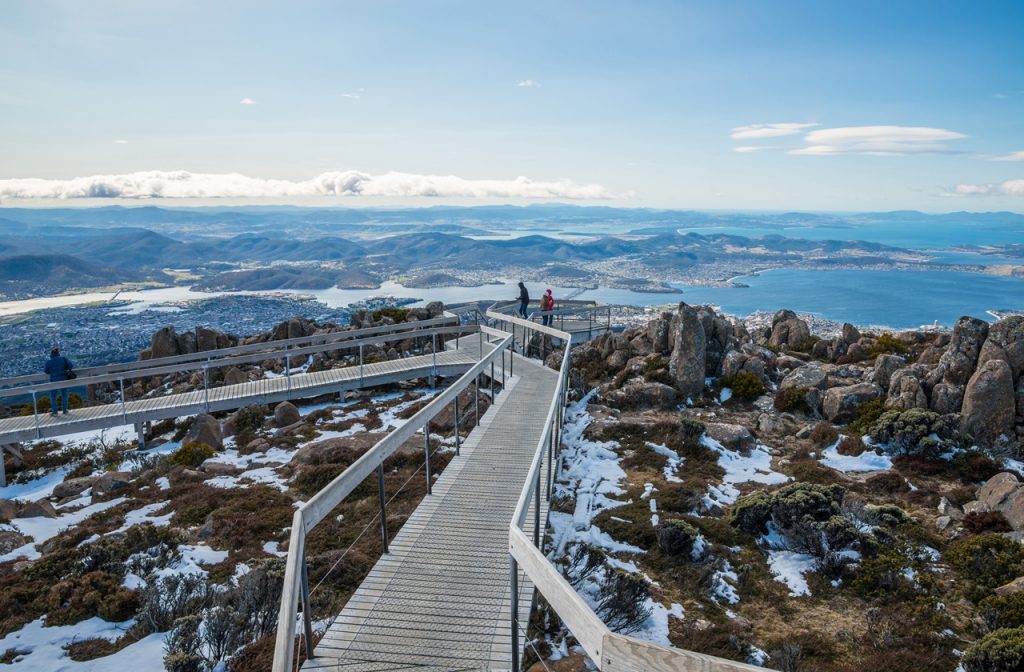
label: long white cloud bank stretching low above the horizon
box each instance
[0,170,614,200]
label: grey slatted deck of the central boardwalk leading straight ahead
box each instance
[302,355,558,672]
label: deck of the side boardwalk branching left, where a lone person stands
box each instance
[0,346,479,446]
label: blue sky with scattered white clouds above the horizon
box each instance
[0,0,1024,212]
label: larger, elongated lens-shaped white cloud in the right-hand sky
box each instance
[790,126,967,156]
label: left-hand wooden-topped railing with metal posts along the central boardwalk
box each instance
[272,326,512,672]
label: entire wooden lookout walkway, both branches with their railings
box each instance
[0,304,760,672]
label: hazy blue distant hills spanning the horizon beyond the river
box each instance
[0,205,1024,297]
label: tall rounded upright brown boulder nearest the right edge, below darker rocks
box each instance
[962,360,1016,446]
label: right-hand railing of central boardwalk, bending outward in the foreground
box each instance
[505,316,763,672]
